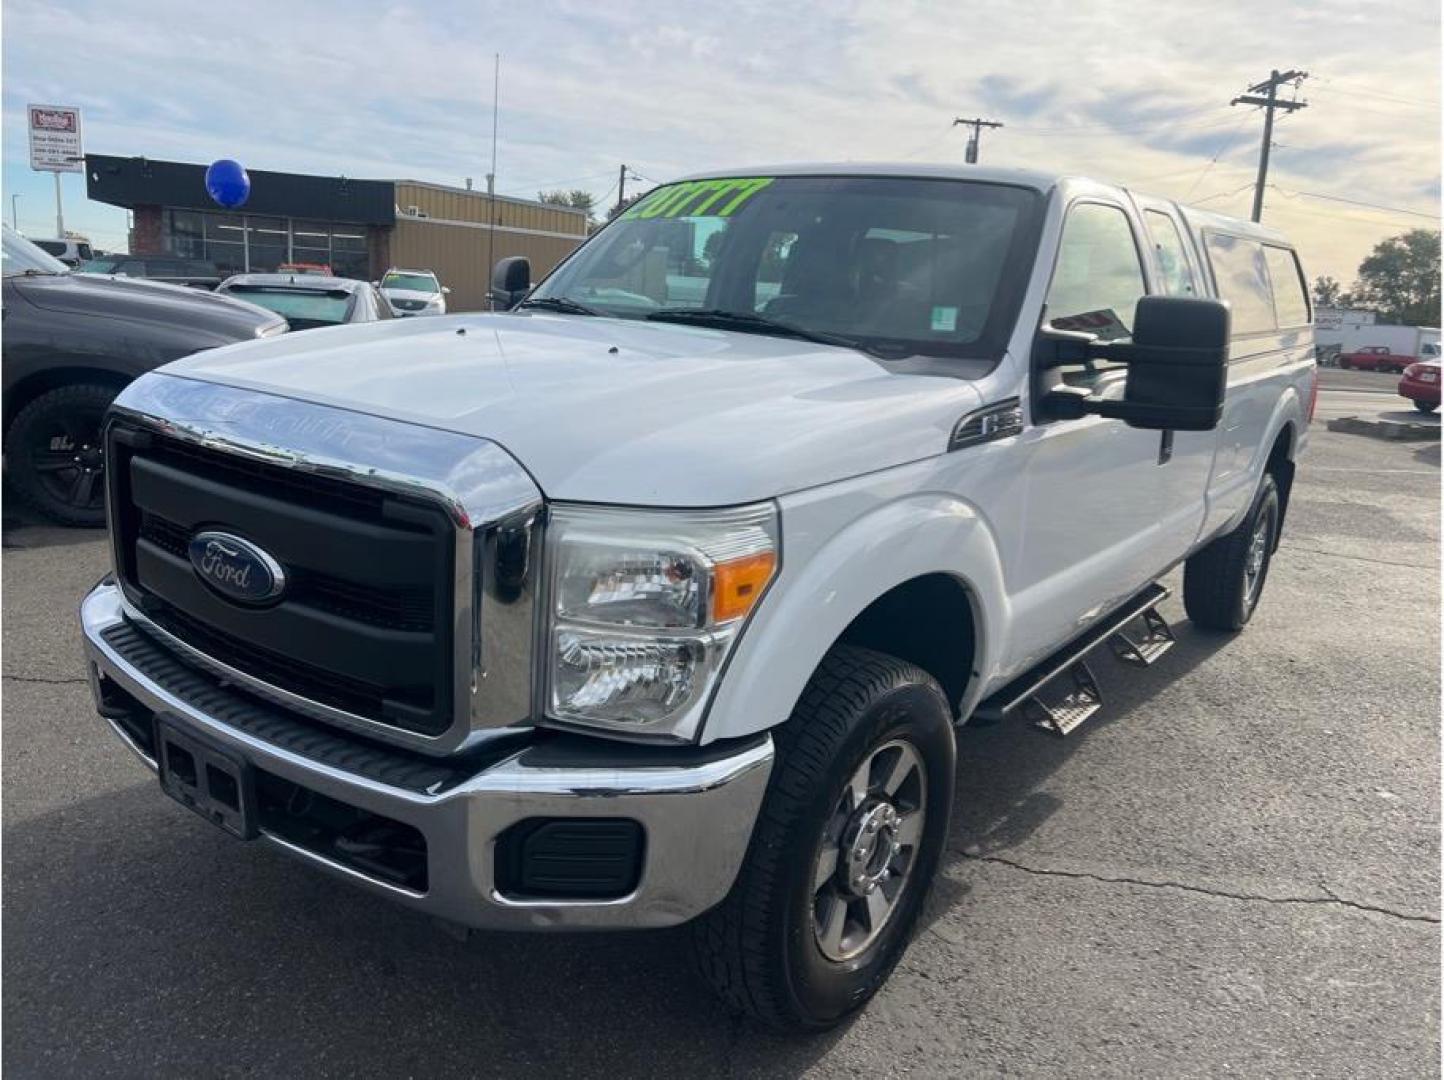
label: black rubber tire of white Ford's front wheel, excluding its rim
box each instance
[693,645,956,1029]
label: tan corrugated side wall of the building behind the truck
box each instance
[388,180,586,312]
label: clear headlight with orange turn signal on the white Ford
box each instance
[546,504,778,736]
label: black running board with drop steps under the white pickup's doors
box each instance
[972,582,1174,735]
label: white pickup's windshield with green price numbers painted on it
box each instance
[530,176,1041,357]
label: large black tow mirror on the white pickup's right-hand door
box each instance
[1038,296,1229,432]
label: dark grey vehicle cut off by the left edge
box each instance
[0,225,286,526]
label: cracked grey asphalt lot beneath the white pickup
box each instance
[3,401,1440,1079]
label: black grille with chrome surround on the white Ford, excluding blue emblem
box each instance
[107,375,542,752]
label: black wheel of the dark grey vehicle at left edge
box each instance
[4,383,118,528]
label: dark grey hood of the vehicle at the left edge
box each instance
[17,273,283,342]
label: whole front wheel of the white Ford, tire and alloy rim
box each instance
[693,645,956,1029]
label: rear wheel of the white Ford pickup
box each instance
[1183,474,1279,631]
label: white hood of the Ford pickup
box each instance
[162,313,979,507]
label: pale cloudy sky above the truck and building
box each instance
[3,0,1440,282]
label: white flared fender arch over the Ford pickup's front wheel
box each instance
[702,485,1008,742]
